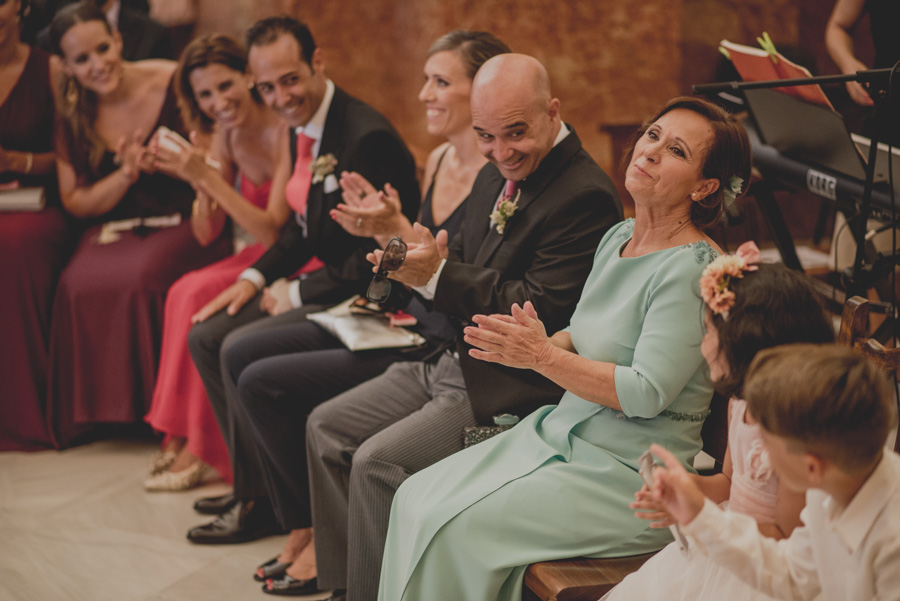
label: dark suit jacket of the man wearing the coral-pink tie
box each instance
[253,87,420,304]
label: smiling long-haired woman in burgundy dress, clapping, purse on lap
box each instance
[48,2,231,446]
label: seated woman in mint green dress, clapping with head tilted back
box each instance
[379,98,750,601]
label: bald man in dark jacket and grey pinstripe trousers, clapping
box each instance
[306,54,621,601]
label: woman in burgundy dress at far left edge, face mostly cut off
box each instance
[0,0,68,451]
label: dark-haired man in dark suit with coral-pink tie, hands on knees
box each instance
[188,17,420,544]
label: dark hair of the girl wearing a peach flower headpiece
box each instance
[707,263,834,397]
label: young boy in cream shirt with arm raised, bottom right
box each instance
[651,344,900,601]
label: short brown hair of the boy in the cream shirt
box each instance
[744,344,895,473]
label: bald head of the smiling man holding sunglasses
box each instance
[472,54,560,181]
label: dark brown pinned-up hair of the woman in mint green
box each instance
[621,96,751,228]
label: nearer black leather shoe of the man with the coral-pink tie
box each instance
[187,500,281,545]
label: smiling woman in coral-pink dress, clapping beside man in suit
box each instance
[145,34,315,490]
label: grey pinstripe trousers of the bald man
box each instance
[306,352,476,601]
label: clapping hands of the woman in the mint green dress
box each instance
[463,301,556,369]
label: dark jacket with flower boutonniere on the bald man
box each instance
[434,126,622,424]
